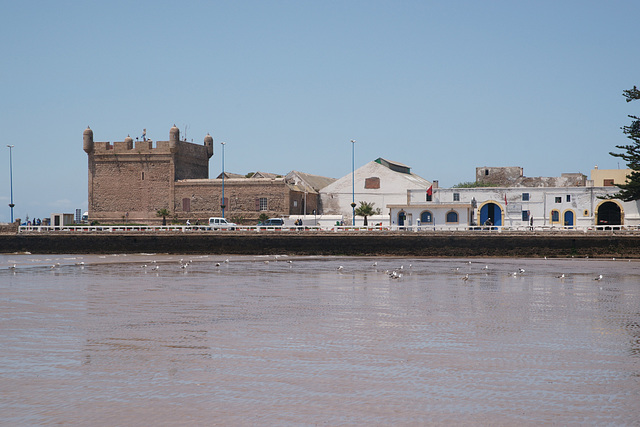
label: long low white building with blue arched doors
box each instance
[387,167,640,229]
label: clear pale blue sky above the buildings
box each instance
[0,0,640,222]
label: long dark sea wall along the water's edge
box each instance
[0,232,640,258]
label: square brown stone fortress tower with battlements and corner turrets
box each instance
[82,125,213,223]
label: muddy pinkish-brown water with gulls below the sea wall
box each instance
[0,254,640,426]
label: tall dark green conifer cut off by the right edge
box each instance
[609,86,640,202]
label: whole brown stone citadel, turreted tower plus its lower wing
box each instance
[83,125,333,224]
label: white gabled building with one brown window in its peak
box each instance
[320,158,431,226]
